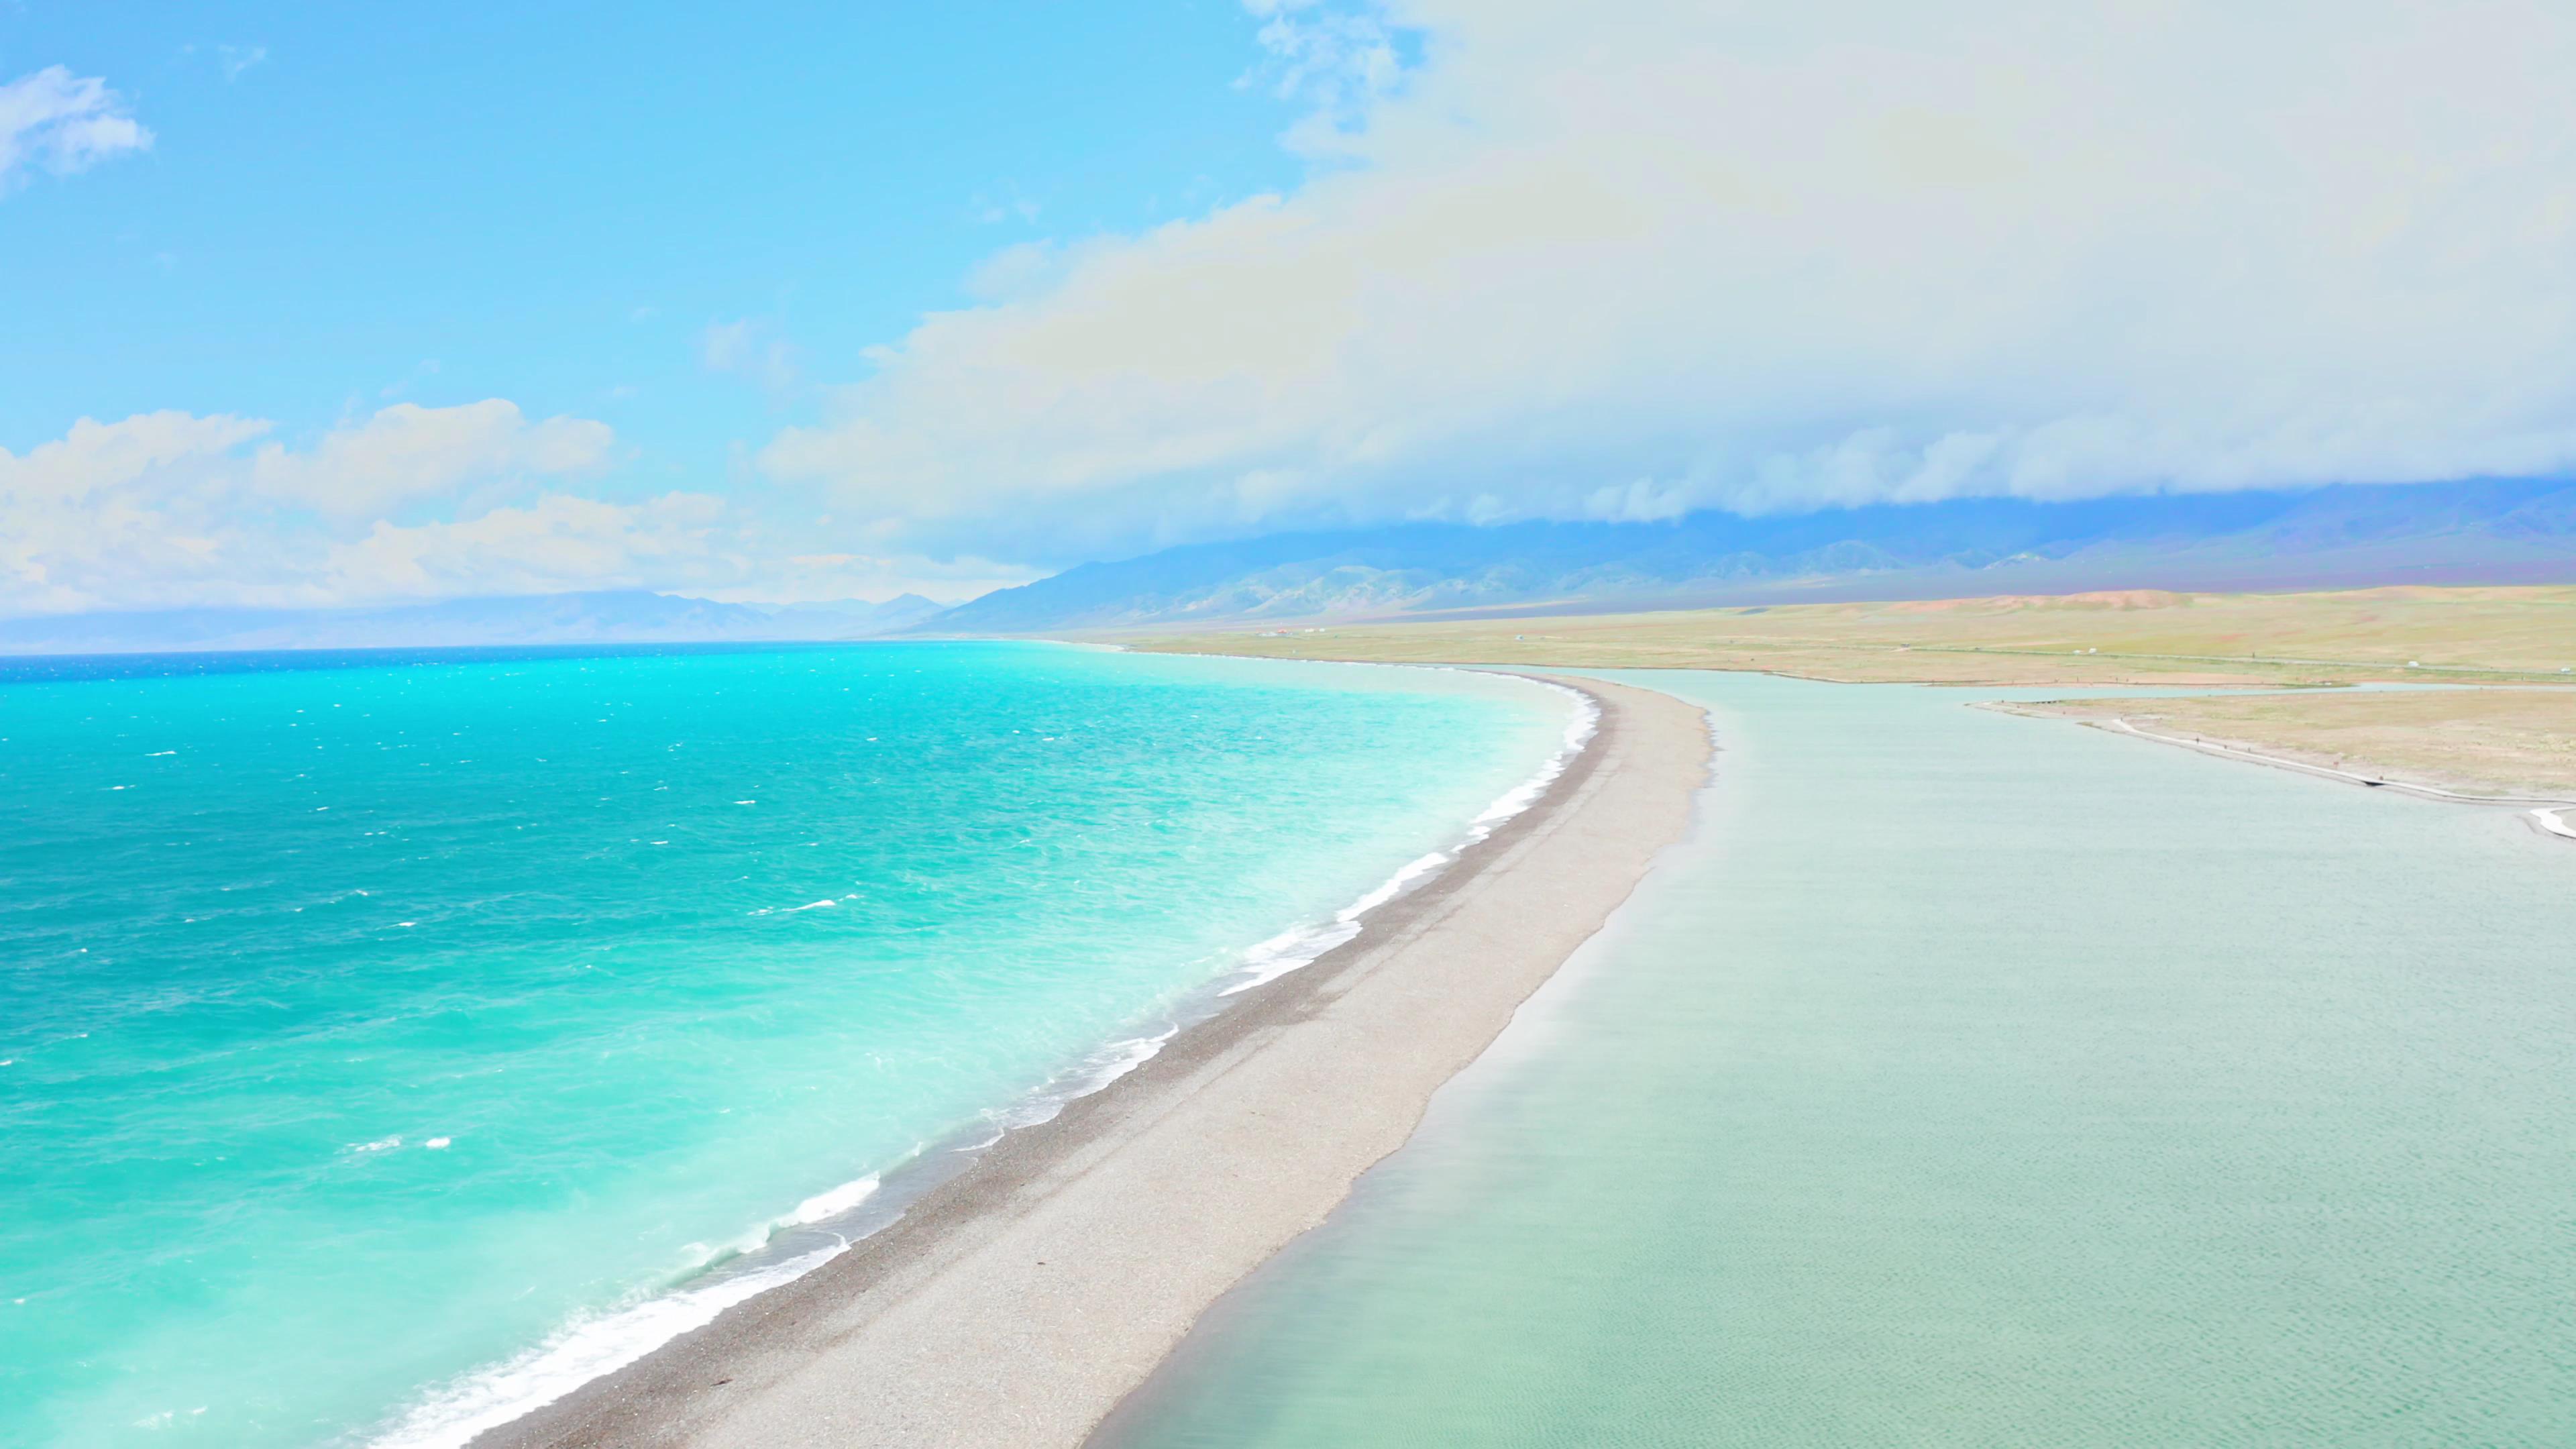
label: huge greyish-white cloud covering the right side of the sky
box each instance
[763,0,2576,559]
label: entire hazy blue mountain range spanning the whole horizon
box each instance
[0,480,2576,655]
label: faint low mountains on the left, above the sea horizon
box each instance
[0,590,941,655]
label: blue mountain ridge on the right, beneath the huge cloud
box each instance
[917,480,2576,634]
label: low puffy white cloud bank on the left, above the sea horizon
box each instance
[0,400,1028,614]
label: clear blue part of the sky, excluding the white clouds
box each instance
[0,0,1298,487]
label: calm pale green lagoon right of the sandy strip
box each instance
[1105,673,2576,1449]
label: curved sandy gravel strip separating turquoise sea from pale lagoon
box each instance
[472,670,1708,1449]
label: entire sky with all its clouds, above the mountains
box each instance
[0,0,2576,614]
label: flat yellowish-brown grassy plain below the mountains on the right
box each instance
[1110,588,2576,792]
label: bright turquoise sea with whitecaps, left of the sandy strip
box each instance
[0,645,1569,1446]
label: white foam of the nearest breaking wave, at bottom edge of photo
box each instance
[371,1240,850,1449]
